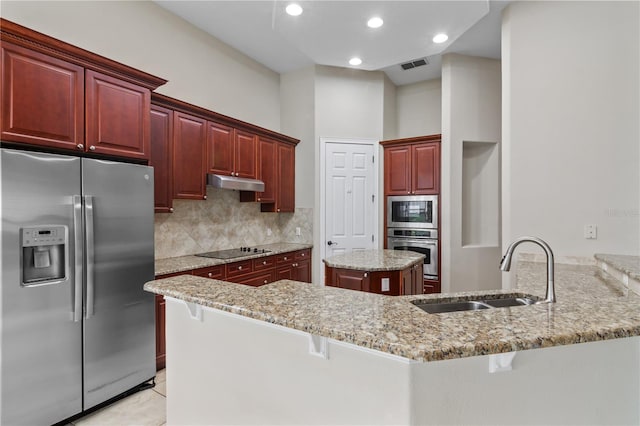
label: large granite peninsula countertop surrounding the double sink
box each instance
[145,262,640,361]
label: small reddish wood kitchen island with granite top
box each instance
[324,250,425,296]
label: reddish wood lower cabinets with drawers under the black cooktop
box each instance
[156,249,311,370]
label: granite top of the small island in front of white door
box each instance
[323,250,424,272]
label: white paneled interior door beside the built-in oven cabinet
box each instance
[322,140,378,258]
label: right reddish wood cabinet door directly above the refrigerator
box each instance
[85,70,151,160]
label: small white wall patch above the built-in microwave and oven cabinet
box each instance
[396,78,442,138]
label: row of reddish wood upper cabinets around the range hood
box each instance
[152,93,299,212]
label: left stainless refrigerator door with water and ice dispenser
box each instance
[0,149,82,425]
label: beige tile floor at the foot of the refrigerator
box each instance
[71,370,167,426]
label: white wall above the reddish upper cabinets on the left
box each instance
[0,0,280,131]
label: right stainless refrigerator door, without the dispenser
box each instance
[82,159,155,410]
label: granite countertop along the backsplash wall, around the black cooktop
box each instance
[155,243,313,276]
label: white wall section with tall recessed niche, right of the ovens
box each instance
[440,54,502,292]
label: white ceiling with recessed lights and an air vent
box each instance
[156,0,509,85]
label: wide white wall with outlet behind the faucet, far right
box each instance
[502,1,640,268]
